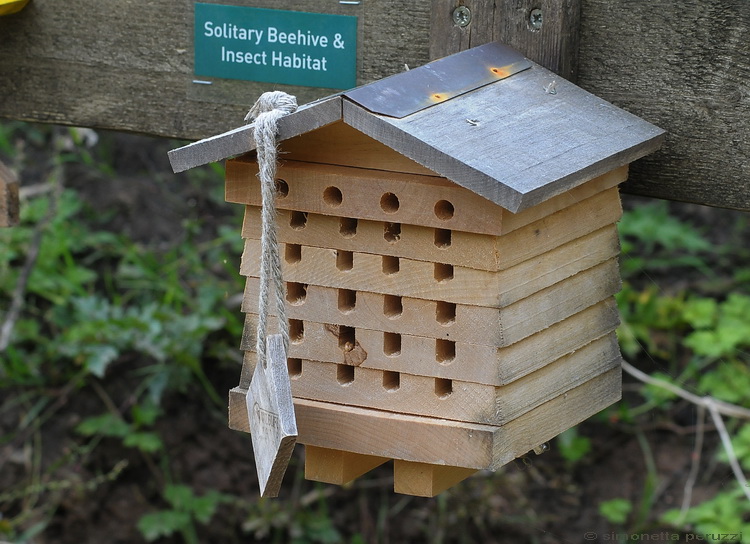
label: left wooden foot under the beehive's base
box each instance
[305,445,389,485]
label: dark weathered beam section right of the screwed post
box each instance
[578,0,750,211]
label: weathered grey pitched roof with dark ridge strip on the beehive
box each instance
[169,44,665,212]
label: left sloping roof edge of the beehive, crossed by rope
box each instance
[167,95,342,174]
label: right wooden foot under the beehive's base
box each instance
[393,459,477,497]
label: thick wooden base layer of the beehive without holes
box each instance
[229,368,622,470]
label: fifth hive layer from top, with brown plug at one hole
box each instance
[241,298,620,386]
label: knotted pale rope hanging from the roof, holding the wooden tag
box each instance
[245,91,297,368]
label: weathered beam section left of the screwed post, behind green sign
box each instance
[0,0,430,139]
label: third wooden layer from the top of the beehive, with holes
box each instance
[240,225,619,308]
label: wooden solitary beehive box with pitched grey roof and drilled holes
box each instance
[171,44,663,496]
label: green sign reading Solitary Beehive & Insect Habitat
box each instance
[195,3,357,89]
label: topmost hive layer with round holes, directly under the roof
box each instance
[226,157,627,235]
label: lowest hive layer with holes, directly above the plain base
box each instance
[292,333,621,425]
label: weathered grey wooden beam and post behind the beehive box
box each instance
[0,0,750,210]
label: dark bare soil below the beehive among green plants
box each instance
[0,129,731,544]
